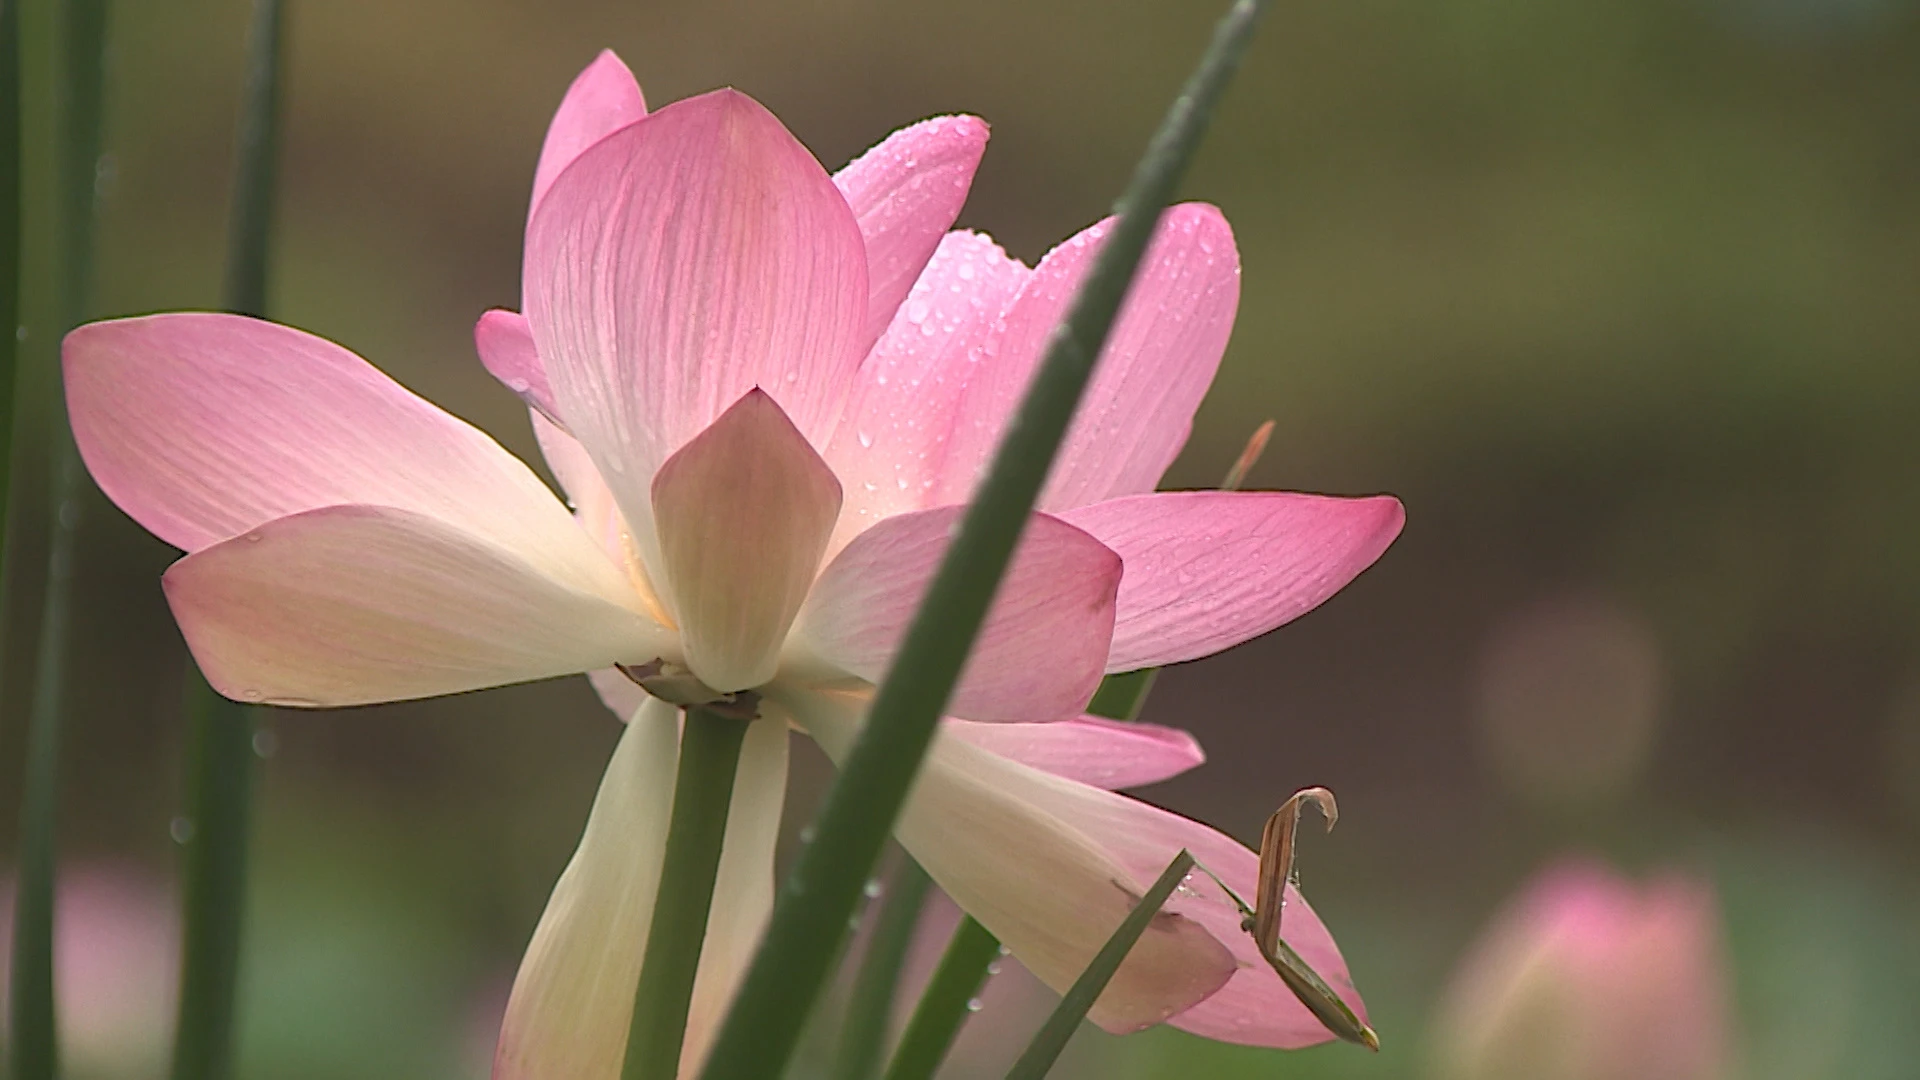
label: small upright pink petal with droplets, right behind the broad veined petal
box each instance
[833,115,987,344]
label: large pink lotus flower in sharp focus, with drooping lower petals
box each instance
[65,54,1402,1080]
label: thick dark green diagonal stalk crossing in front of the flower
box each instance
[703,0,1263,1080]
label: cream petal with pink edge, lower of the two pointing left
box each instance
[163,505,674,707]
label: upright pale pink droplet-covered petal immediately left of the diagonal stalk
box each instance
[826,233,1031,550]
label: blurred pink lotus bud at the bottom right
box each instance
[1434,861,1732,1080]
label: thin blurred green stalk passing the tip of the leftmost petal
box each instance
[12,0,108,1080]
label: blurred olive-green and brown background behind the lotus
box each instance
[0,0,1920,1080]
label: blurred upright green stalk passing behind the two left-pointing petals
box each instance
[173,0,284,1080]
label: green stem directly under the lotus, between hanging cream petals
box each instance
[620,707,753,1080]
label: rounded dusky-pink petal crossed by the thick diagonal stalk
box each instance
[799,507,1119,721]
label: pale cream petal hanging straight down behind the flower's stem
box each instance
[493,698,787,1080]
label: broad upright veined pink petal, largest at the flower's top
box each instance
[524,90,866,532]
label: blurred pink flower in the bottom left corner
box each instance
[0,863,180,1076]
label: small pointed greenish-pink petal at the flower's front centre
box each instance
[653,390,841,692]
